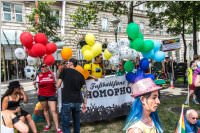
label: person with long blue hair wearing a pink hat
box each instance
[123,78,163,133]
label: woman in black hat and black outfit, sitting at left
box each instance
[1,80,37,133]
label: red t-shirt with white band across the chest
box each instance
[36,71,56,96]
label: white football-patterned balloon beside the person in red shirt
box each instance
[24,66,36,80]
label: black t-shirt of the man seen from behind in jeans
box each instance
[59,68,85,103]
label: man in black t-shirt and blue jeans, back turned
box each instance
[56,58,86,133]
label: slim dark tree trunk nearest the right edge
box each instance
[192,9,197,55]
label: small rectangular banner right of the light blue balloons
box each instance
[162,38,181,51]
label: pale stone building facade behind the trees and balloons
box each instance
[0,1,192,81]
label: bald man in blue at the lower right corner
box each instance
[184,109,200,133]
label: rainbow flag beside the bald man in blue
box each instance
[175,105,186,133]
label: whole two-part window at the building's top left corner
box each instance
[3,2,23,22]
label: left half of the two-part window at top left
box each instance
[3,2,11,21]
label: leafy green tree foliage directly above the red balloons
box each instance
[27,1,61,42]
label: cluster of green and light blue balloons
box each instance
[126,23,165,62]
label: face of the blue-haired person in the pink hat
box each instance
[141,91,160,112]
